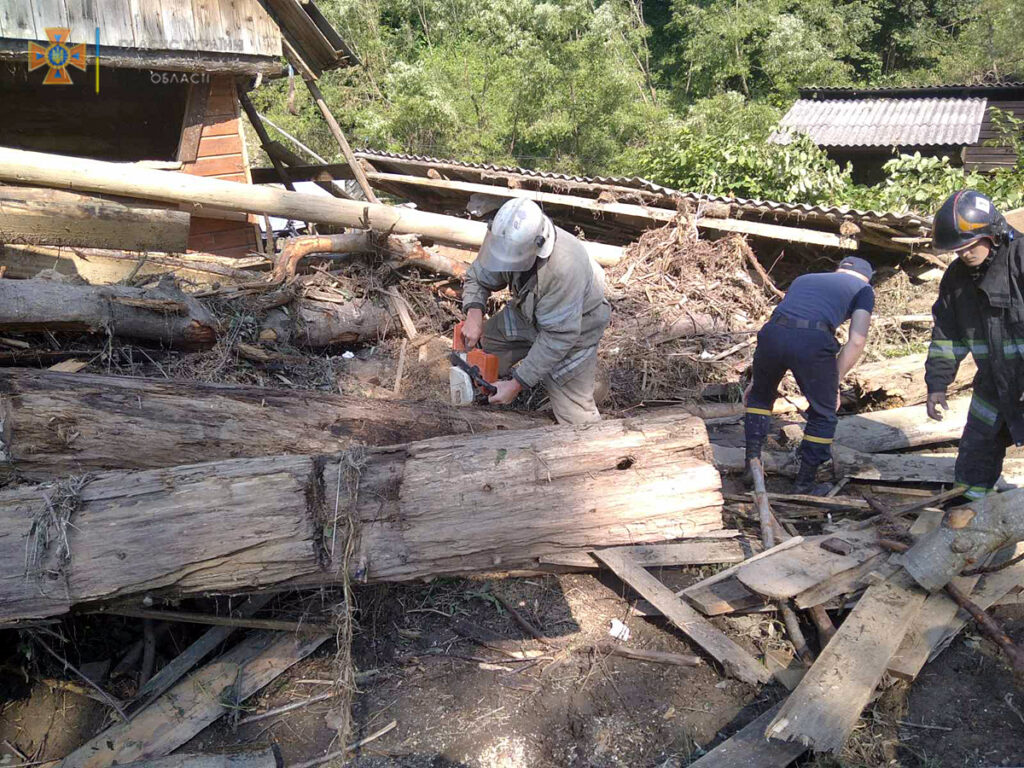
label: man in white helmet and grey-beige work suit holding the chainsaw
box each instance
[462,198,611,424]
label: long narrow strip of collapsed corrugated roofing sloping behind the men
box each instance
[355,148,932,229]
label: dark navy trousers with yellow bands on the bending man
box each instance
[743,323,839,467]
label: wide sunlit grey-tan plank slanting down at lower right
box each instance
[765,572,927,753]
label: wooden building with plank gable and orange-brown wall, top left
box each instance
[0,0,354,256]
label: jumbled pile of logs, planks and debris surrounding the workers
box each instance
[0,141,1024,766]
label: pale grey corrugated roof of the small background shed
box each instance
[770,98,987,146]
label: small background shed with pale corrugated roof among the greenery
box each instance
[769,83,1024,183]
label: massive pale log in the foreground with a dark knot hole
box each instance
[0,413,722,622]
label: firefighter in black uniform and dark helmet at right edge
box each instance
[925,189,1024,499]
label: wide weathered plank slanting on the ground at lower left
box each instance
[59,632,333,768]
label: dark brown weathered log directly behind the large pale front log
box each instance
[0,369,548,480]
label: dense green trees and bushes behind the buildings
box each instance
[249,0,1024,210]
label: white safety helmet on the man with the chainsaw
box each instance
[477,198,555,272]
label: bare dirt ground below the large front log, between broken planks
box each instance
[8,568,1024,768]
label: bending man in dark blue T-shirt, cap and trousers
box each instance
[743,256,874,496]
